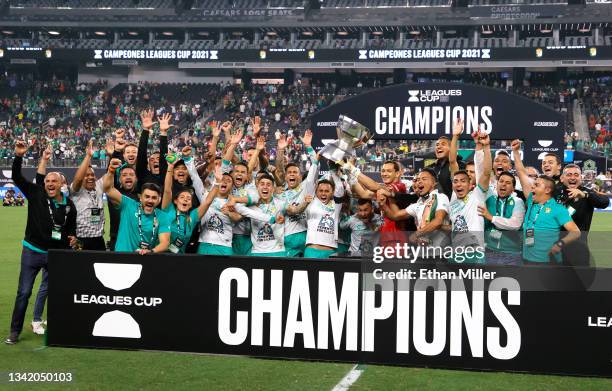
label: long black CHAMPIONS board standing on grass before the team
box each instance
[48,251,612,376]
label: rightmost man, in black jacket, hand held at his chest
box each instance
[560,164,610,266]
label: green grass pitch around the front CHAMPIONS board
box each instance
[0,208,612,390]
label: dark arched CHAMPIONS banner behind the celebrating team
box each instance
[311,83,565,167]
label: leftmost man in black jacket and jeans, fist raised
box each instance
[5,141,76,345]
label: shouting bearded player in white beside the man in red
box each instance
[381,168,449,247]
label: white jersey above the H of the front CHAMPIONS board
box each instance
[236,198,286,254]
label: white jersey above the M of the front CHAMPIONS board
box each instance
[306,198,342,248]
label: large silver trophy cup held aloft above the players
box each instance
[321,115,372,162]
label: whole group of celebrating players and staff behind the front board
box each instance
[6,110,609,344]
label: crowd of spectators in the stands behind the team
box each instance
[0,75,612,171]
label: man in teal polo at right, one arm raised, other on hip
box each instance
[512,140,580,265]
